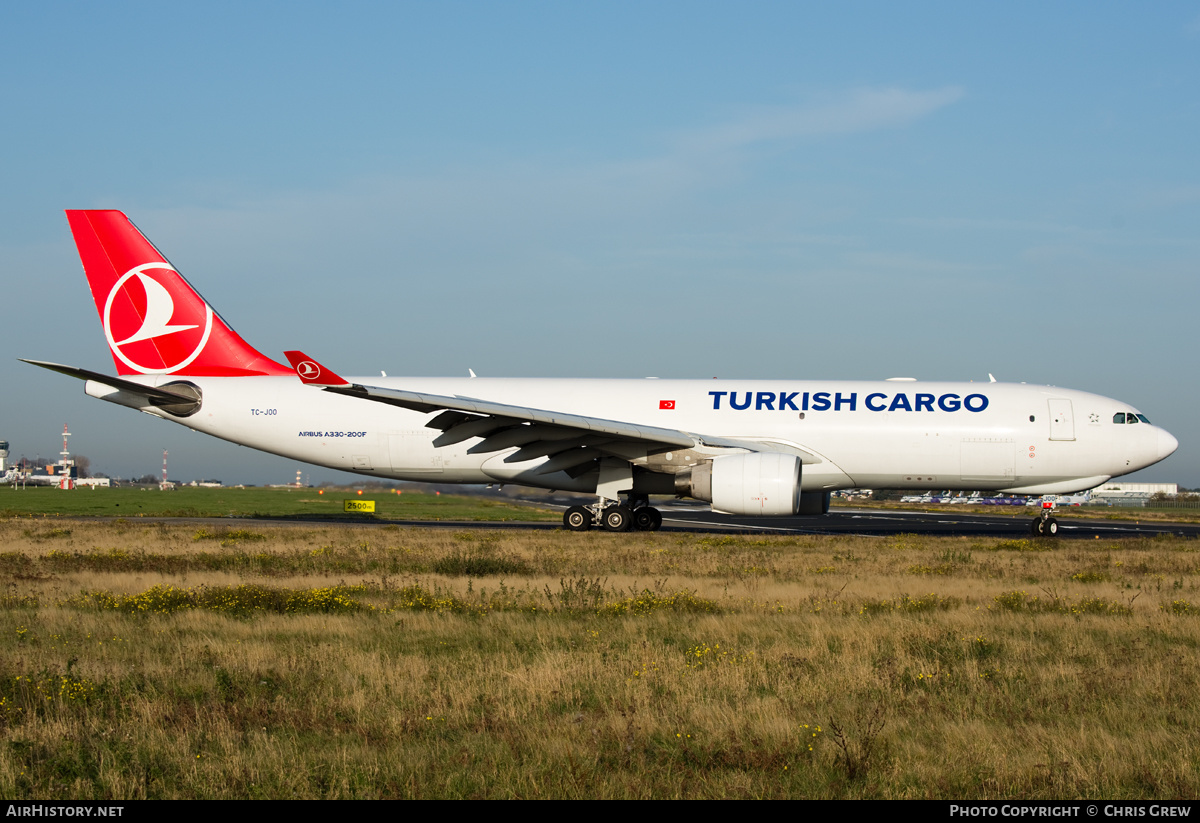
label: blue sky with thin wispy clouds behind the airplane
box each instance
[0,2,1200,486]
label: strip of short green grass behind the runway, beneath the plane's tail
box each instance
[0,486,562,521]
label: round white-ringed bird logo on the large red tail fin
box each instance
[102,263,212,374]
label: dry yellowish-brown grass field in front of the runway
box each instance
[0,523,1200,800]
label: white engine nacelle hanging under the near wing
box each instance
[676,451,800,515]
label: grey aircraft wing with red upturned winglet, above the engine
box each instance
[284,352,821,474]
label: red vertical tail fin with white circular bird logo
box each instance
[67,210,293,377]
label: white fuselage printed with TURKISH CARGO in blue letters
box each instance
[96,376,1177,493]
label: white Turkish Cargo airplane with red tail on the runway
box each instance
[25,210,1178,535]
